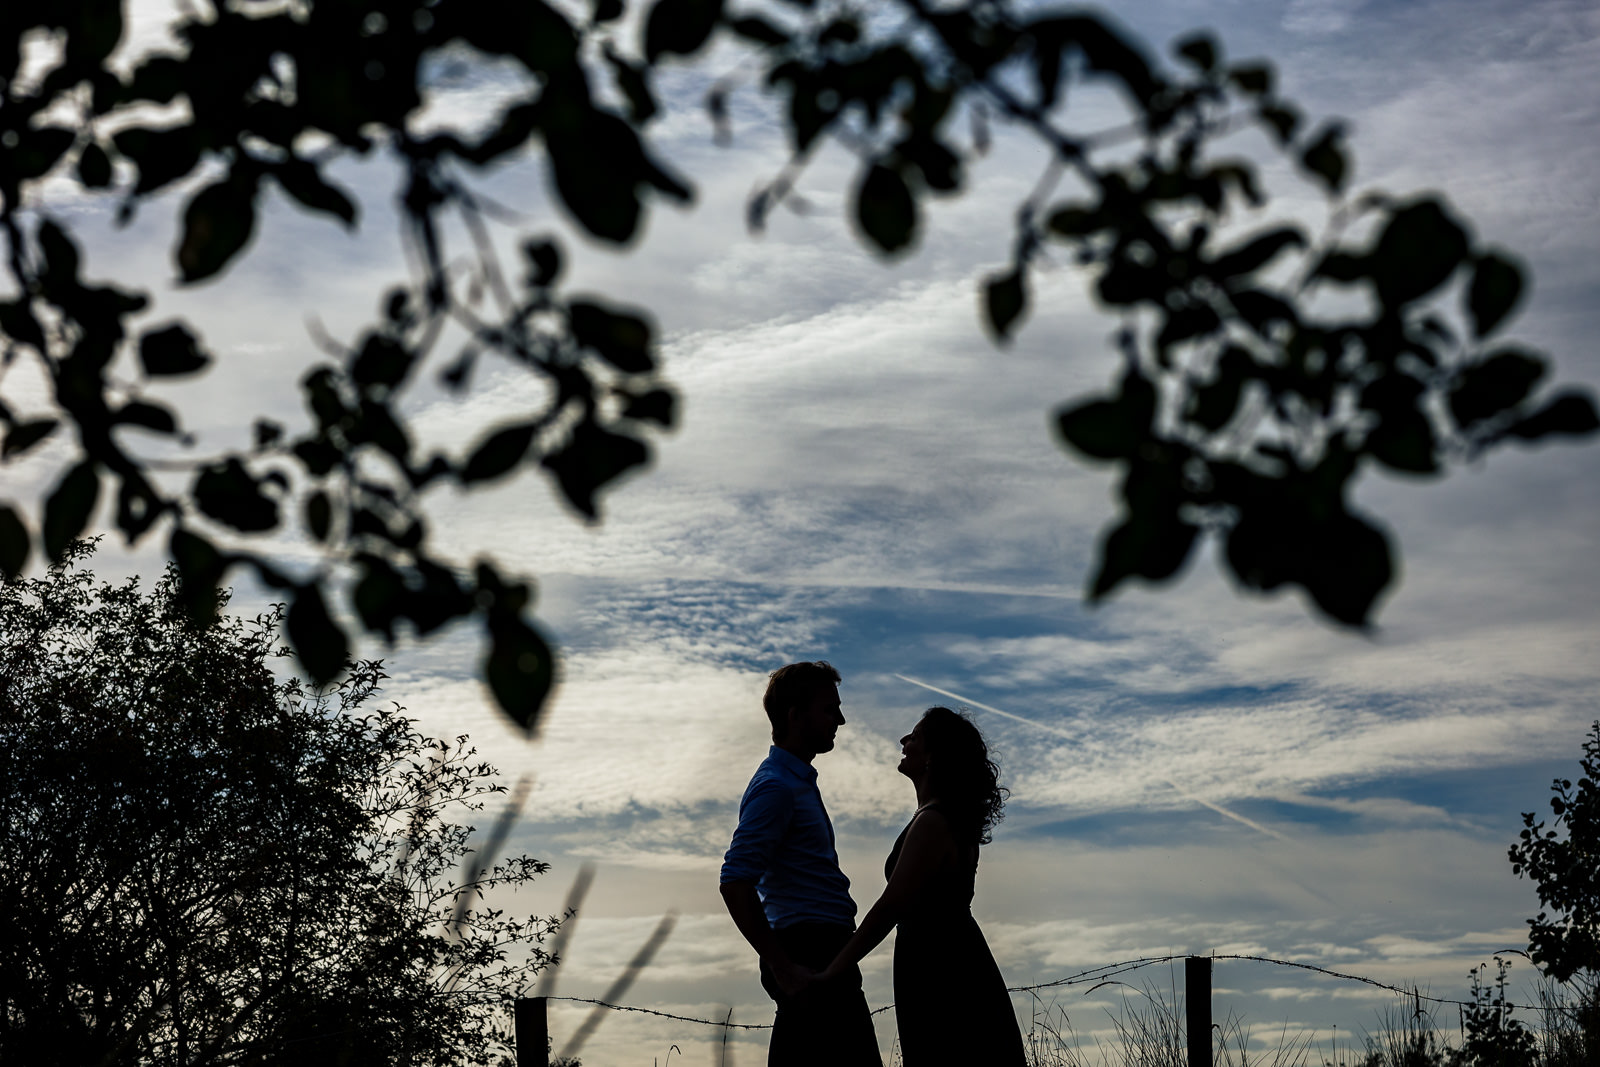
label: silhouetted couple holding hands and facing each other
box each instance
[722,662,1024,1067]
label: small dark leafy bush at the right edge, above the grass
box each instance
[1510,721,1600,982]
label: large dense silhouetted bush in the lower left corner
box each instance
[0,542,554,1067]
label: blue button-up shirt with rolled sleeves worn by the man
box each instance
[722,745,856,929]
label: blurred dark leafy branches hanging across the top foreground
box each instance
[0,0,1600,728]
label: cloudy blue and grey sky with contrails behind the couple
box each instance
[0,0,1600,1065]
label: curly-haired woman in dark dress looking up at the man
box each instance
[819,707,1026,1067]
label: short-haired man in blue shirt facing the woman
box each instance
[722,661,883,1067]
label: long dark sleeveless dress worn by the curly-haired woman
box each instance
[883,805,1026,1067]
